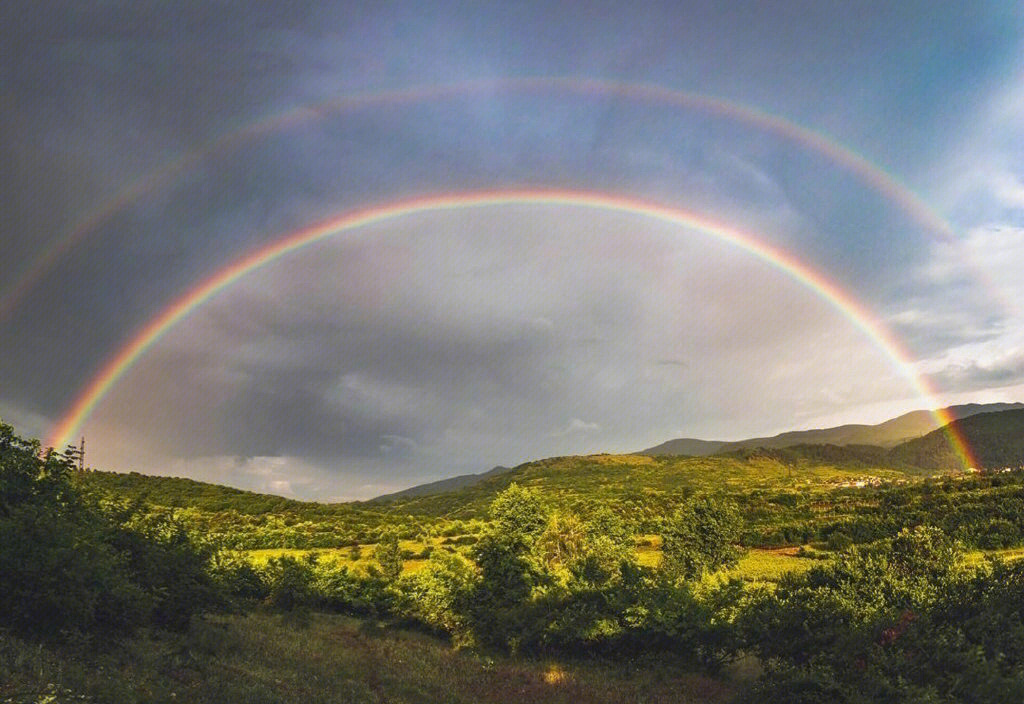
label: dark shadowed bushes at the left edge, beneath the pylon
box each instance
[0,423,217,636]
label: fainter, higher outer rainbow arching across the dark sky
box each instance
[0,77,1014,320]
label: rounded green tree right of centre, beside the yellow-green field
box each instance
[662,496,742,579]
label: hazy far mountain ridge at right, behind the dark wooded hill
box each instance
[638,403,1024,456]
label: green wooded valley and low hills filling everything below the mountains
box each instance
[6,413,1024,702]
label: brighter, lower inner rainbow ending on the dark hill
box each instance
[49,190,976,467]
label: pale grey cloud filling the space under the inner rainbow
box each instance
[74,208,921,497]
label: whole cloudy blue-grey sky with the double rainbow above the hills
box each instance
[0,0,1024,501]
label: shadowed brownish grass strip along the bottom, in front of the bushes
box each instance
[0,612,736,704]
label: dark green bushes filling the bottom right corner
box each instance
[742,527,1024,702]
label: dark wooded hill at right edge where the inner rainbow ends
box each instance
[890,409,1024,471]
